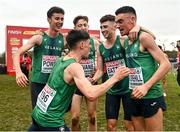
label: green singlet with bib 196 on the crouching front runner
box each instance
[32,57,76,127]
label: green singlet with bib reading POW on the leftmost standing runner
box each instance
[32,32,64,84]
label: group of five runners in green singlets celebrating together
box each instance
[13,6,171,131]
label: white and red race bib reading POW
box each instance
[41,55,58,73]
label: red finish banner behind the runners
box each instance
[6,26,100,75]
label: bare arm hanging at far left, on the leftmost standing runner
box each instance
[13,35,42,87]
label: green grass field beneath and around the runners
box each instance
[0,74,180,131]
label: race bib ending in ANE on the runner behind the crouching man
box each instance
[80,59,95,77]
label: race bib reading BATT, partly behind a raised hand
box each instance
[105,59,125,78]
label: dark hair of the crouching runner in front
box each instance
[66,30,90,49]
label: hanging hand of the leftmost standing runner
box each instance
[16,72,29,87]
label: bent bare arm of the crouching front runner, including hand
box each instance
[64,63,129,101]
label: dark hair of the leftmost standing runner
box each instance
[47,6,65,18]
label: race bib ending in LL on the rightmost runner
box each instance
[129,67,144,89]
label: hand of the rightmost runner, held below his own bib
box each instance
[132,84,148,99]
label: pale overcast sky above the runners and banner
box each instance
[0,0,180,53]
